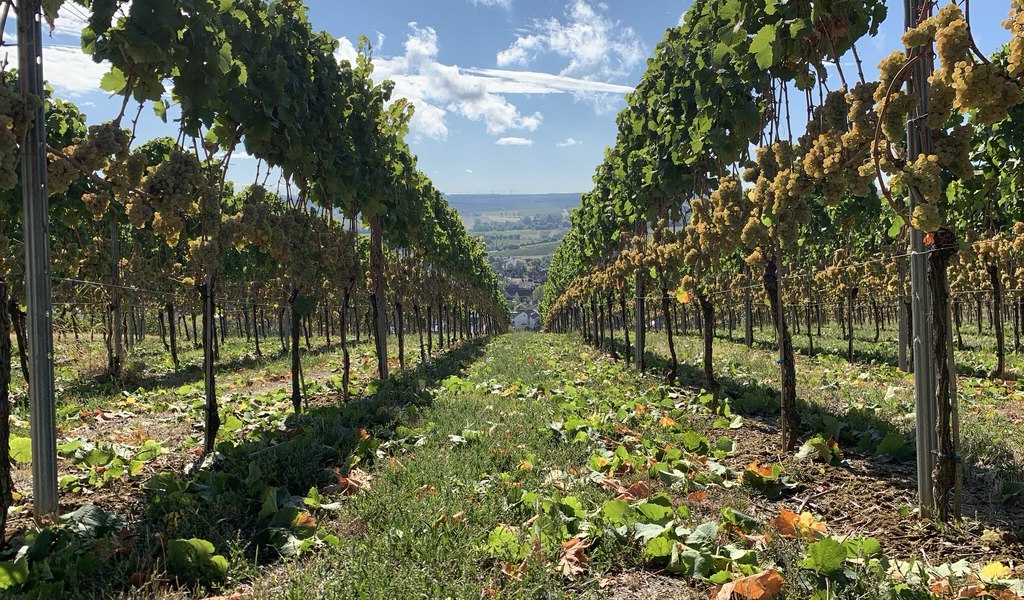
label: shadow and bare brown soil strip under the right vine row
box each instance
[593,331,1024,555]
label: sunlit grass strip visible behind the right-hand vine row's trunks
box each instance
[634,319,1024,478]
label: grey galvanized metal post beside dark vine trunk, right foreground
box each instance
[904,0,936,516]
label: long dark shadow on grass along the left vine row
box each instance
[0,339,488,598]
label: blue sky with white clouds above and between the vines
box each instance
[0,0,1010,194]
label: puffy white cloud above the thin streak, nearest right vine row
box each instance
[498,0,647,81]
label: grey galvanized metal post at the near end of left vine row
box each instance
[17,0,57,520]
